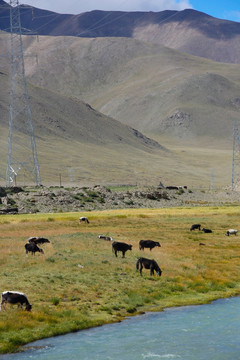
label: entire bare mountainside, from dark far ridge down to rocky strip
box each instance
[0,1,240,187]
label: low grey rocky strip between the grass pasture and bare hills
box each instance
[0,185,240,216]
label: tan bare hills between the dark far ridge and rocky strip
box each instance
[0,34,240,186]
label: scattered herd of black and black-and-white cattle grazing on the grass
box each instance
[0,217,238,311]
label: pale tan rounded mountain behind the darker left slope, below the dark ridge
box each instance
[10,33,240,138]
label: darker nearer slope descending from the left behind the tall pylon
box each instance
[0,67,169,184]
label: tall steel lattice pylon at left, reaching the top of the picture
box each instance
[6,0,41,186]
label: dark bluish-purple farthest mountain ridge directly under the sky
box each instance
[0,0,240,64]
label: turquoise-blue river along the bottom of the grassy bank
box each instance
[0,297,240,360]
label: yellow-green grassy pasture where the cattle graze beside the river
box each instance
[0,206,240,353]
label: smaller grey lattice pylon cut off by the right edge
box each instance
[232,120,240,190]
